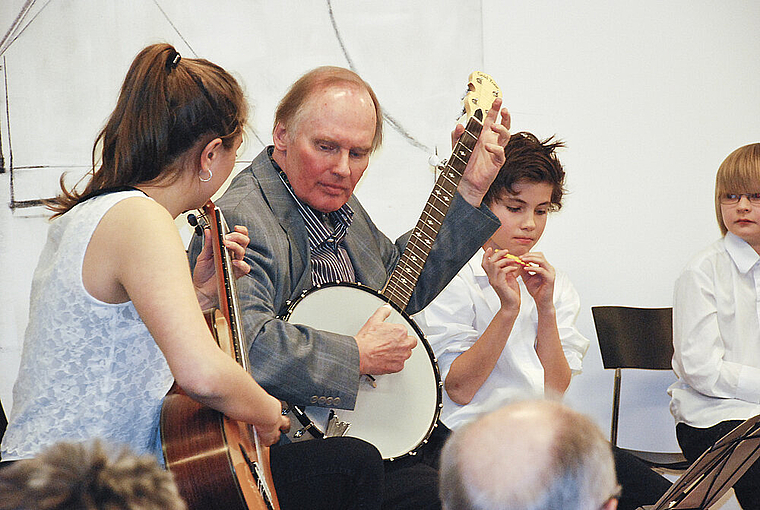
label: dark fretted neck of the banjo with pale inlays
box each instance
[382,110,483,310]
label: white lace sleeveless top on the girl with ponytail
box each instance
[2,191,173,460]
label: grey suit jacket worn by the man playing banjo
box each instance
[190,149,499,409]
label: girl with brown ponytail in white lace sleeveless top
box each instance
[2,40,288,461]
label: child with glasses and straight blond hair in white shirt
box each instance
[668,143,760,509]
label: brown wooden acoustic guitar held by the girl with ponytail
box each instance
[161,201,280,510]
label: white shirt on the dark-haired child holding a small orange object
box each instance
[415,249,589,429]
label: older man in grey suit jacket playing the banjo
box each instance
[191,67,509,508]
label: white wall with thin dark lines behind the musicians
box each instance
[0,0,760,462]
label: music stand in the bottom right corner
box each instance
[640,415,760,510]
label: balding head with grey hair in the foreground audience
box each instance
[440,400,618,510]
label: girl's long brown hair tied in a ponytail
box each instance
[47,44,248,217]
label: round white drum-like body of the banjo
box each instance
[283,283,442,460]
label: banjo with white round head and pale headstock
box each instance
[282,71,501,460]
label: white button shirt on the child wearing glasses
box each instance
[668,232,760,428]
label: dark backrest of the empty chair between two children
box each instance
[591,306,673,370]
